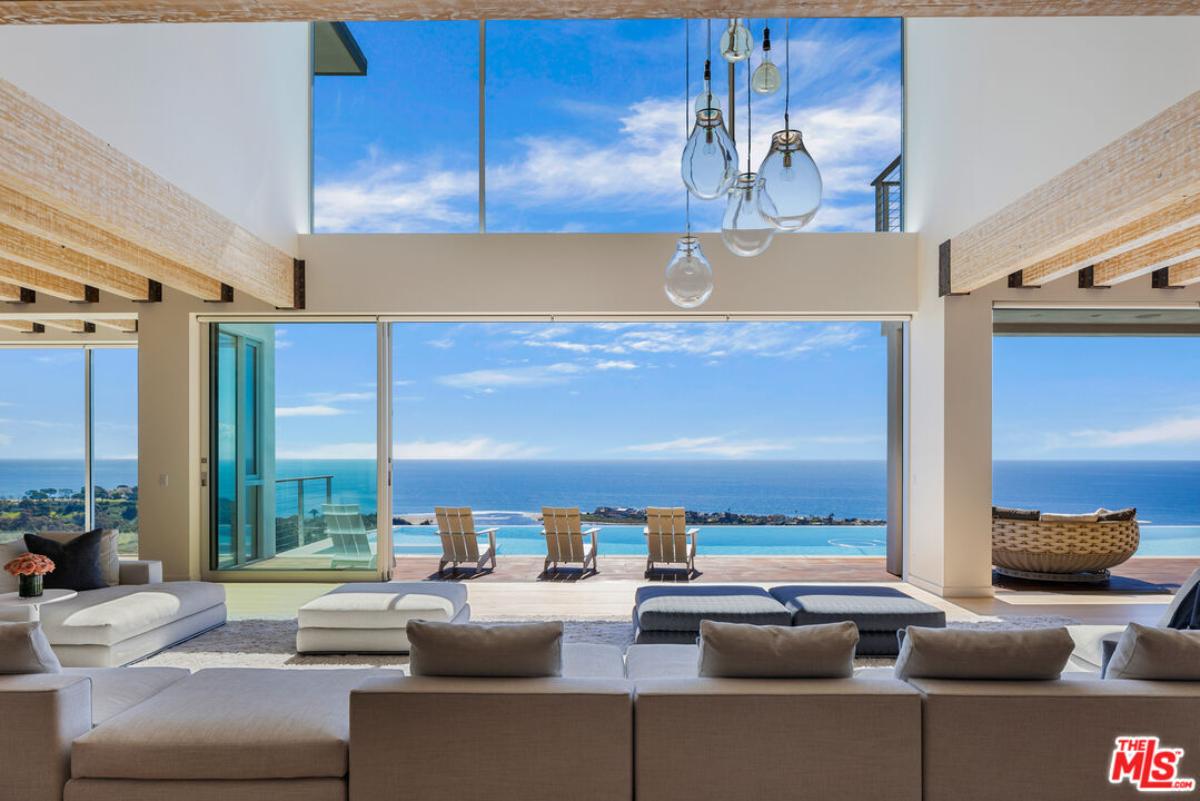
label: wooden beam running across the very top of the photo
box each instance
[0,0,1196,24]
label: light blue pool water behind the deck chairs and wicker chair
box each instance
[392,525,1200,556]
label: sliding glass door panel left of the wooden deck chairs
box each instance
[209,323,386,572]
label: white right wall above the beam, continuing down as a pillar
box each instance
[905,17,1200,595]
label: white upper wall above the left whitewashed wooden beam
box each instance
[0,23,311,253]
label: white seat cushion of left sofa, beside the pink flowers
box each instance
[42,582,224,645]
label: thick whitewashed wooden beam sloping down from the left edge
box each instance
[0,80,302,308]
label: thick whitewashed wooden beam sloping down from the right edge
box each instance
[941,91,1200,294]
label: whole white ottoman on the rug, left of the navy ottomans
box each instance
[296,582,470,654]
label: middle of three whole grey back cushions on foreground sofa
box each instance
[700,620,858,679]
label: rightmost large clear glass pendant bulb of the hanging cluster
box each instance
[758,130,822,231]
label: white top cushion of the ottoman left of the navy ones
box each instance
[298,582,467,628]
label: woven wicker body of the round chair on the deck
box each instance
[991,518,1140,582]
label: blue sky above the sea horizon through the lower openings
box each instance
[0,323,1200,459]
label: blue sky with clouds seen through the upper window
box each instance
[313,19,901,231]
